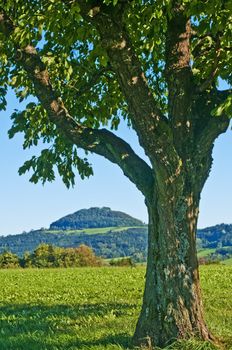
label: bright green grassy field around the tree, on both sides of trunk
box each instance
[0,265,232,350]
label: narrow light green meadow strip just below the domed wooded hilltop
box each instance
[45,226,146,235]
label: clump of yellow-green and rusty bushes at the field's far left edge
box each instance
[0,244,102,268]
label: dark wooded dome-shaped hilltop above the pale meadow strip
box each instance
[50,207,144,230]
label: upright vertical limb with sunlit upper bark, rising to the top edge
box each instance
[165,1,198,158]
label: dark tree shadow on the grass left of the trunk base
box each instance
[0,303,136,350]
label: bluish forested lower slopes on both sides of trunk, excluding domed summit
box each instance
[0,224,232,261]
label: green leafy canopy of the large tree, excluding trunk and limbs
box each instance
[0,0,232,186]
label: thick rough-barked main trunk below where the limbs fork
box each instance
[134,174,212,347]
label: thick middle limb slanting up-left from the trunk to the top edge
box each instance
[74,1,172,165]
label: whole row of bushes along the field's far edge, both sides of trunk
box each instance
[0,243,232,269]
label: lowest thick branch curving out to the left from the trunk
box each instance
[0,13,153,198]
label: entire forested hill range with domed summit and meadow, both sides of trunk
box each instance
[0,208,232,261]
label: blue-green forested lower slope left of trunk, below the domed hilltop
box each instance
[0,226,147,261]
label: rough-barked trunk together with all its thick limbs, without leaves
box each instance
[0,0,229,347]
